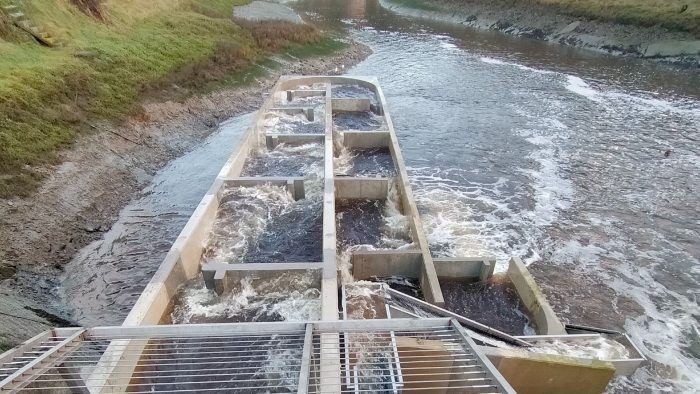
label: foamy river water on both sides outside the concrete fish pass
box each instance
[61,0,700,393]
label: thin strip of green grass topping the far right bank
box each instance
[400,0,700,35]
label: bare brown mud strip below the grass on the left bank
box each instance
[0,44,371,349]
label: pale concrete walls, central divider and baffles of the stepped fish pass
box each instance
[124,77,444,325]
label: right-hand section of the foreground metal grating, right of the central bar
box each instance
[310,323,504,393]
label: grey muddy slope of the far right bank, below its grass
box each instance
[379,0,700,67]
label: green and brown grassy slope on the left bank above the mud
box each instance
[0,0,340,198]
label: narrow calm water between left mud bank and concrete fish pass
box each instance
[57,114,254,326]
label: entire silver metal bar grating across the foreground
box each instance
[0,319,513,393]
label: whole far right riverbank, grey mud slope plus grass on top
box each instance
[380,0,700,67]
